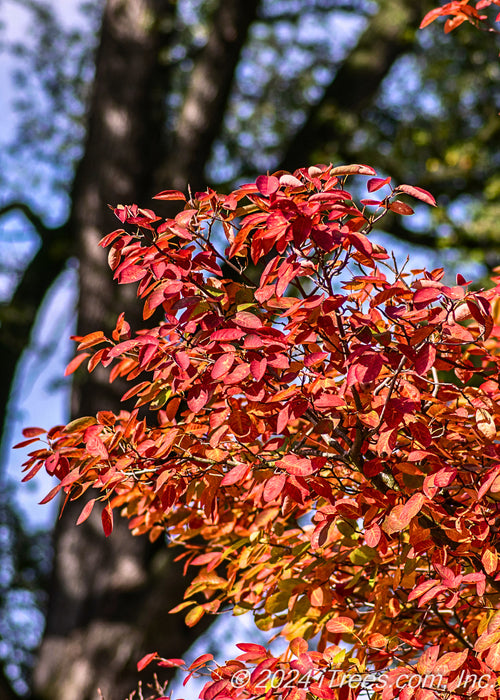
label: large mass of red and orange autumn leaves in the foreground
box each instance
[15,165,500,700]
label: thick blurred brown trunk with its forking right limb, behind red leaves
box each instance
[33,0,258,700]
